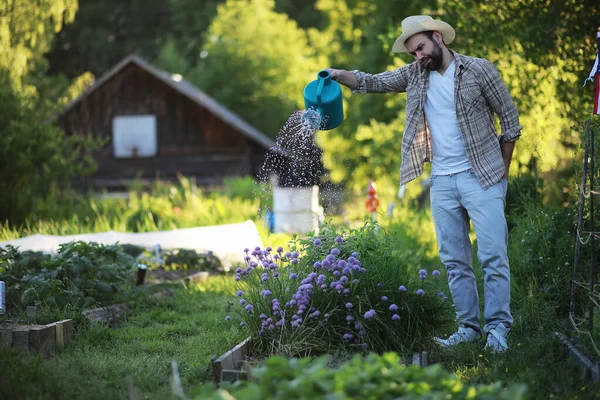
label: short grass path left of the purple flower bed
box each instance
[0,278,243,399]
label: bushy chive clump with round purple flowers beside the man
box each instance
[228,224,452,356]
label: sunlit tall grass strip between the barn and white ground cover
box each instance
[0,177,274,241]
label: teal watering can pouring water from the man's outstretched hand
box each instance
[303,69,344,131]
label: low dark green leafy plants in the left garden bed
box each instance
[0,242,135,309]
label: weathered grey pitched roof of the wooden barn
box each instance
[62,54,275,149]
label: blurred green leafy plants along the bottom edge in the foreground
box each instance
[195,353,527,400]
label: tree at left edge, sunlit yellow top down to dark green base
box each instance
[0,0,97,224]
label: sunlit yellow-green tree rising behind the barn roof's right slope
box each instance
[188,0,325,137]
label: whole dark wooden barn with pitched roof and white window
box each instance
[58,55,274,190]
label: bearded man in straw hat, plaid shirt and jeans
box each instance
[329,15,522,352]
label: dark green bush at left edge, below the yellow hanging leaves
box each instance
[0,69,99,224]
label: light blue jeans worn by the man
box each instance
[430,169,513,333]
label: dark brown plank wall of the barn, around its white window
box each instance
[59,64,265,187]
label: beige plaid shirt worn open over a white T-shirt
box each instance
[352,51,523,190]
